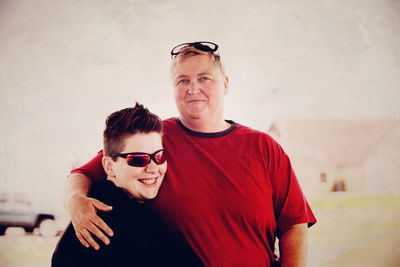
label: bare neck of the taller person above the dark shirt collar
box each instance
[179,116,230,133]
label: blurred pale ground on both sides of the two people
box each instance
[0,193,400,267]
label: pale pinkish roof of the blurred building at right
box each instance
[271,119,400,165]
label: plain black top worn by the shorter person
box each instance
[52,181,204,267]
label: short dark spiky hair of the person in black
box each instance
[103,102,162,156]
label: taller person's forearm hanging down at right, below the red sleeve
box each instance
[279,223,307,267]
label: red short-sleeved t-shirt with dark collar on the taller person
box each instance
[72,118,316,267]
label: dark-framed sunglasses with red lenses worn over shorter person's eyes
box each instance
[110,149,167,167]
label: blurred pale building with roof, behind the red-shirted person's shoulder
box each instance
[268,120,400,195]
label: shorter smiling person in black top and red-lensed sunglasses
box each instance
[52,104,204,267]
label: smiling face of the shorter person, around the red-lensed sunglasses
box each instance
[103,132,167,201]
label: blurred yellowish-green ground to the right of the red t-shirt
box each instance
[308,193,400,267]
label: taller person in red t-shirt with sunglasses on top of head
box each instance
[66,42,316,267]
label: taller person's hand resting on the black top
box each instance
[69,195,114,250]
